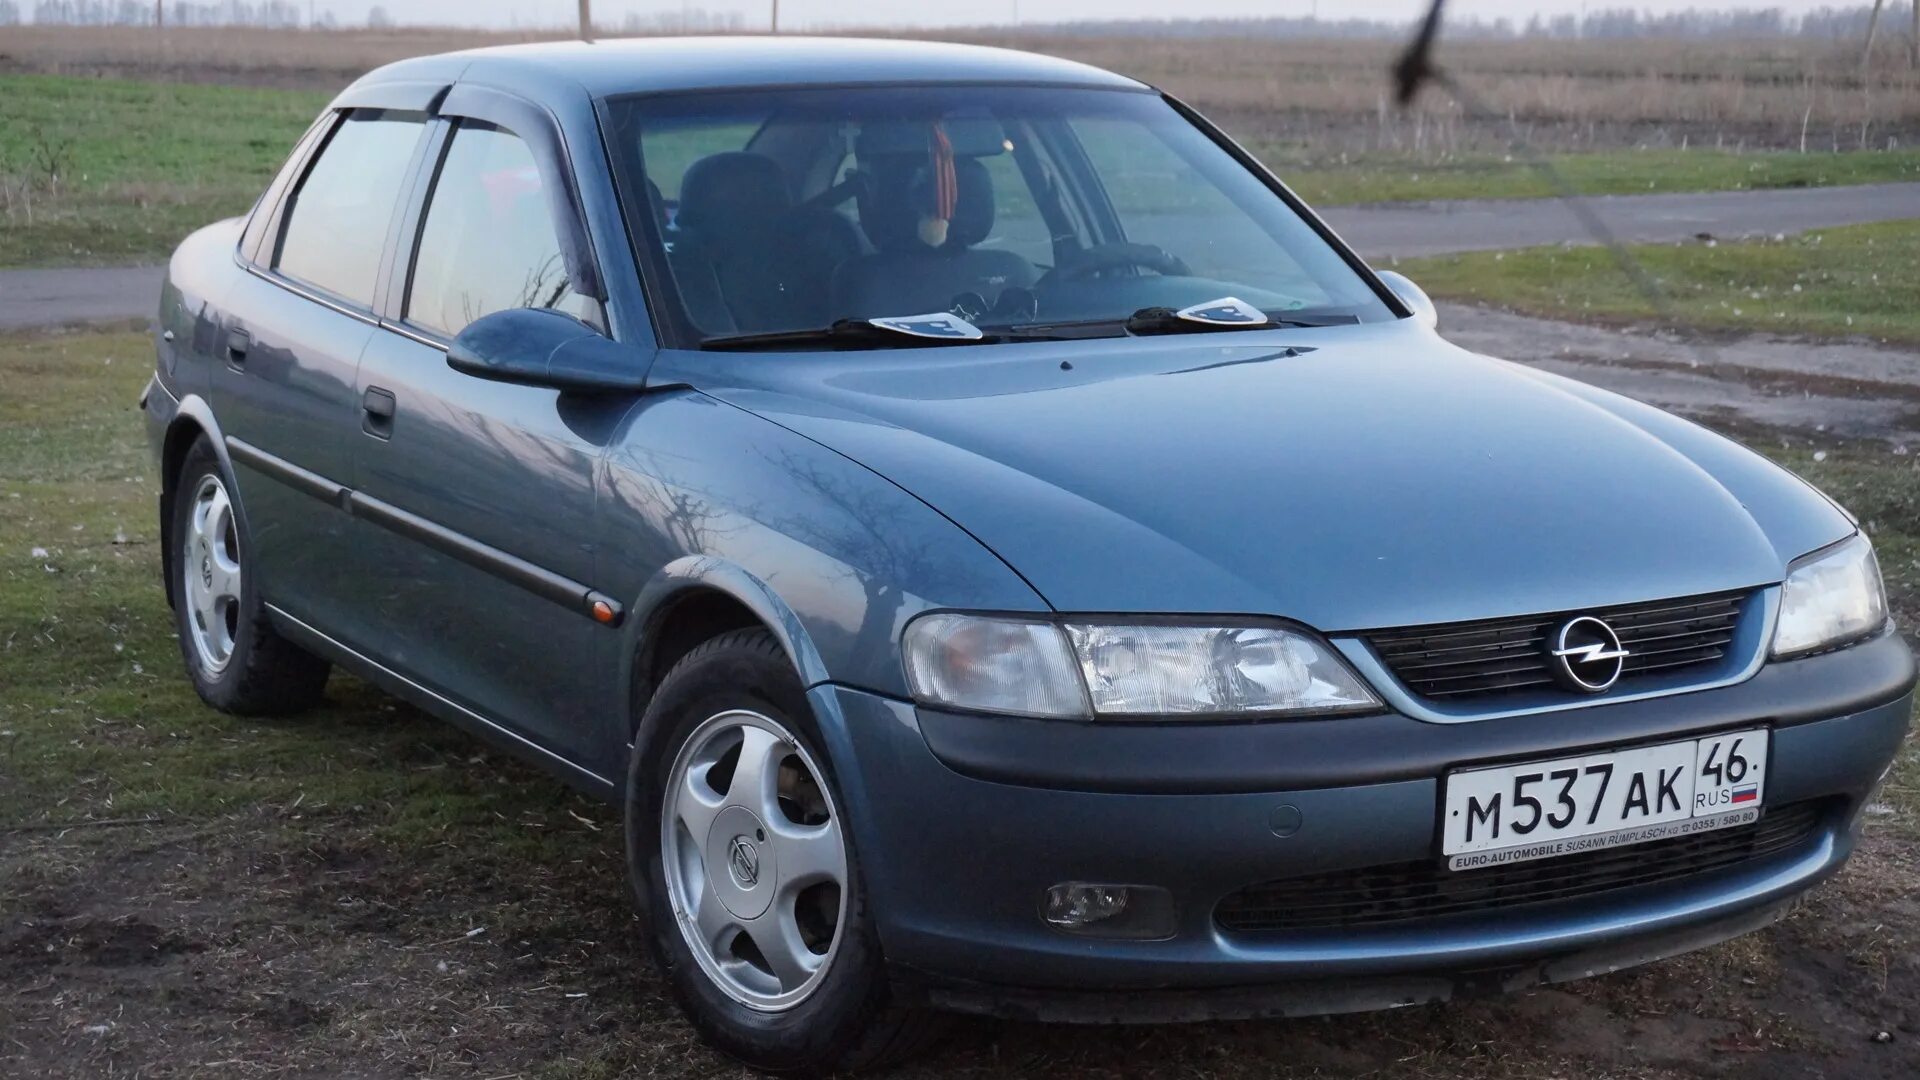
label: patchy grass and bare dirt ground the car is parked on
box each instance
[0,332,1920,1080]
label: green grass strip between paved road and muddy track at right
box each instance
[1400,221,1920,346]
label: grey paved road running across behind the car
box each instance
[0,184,1920,331]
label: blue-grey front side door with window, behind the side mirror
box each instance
[353,88,632,763]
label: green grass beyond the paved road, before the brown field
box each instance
[0,75,1920,267]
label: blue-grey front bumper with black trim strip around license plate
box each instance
[812,634,1914,1020]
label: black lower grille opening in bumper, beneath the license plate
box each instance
[1213,799,1824,930]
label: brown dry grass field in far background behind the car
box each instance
[0,27,1920,160]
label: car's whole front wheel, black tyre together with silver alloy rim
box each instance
[626,630,937,1074]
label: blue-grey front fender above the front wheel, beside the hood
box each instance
[601,390,1046,698]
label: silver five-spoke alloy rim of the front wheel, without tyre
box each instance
[660,709,847,1011]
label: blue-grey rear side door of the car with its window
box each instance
[209,108,426,628]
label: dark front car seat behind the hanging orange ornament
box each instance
[833,158,1037,319]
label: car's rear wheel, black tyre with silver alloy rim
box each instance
[167,436,328,717]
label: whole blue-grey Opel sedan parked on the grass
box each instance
[144,38,1914,1072]
